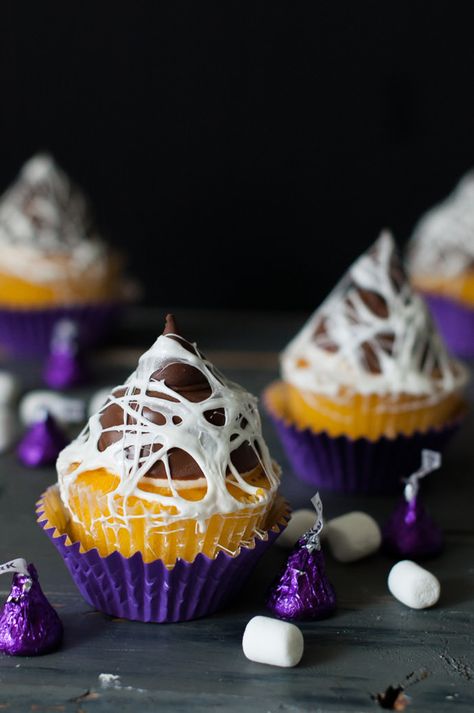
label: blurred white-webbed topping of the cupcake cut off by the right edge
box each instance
[408,172,474,278]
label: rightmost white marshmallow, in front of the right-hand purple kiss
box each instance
[387,560,441,609]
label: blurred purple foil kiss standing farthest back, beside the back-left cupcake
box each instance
[43,319,86,389]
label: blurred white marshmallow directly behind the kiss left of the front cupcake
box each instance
[20,391,85,426]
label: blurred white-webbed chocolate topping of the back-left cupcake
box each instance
[0,154,106,283]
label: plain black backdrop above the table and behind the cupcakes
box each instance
[0,0,474,309]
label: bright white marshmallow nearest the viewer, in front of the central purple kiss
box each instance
[242,616,306,667]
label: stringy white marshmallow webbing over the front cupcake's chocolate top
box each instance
[57,324,279,525]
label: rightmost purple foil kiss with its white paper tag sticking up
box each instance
[382,450,443,559]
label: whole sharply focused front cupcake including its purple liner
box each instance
[40,316,286,621]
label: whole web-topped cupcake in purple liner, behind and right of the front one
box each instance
[266,232,467,491]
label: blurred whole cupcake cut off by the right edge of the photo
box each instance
[408,173,474,357]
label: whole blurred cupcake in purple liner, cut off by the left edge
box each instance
[0,155,123,353]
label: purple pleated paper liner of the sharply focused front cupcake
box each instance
[37,486,289,623]
